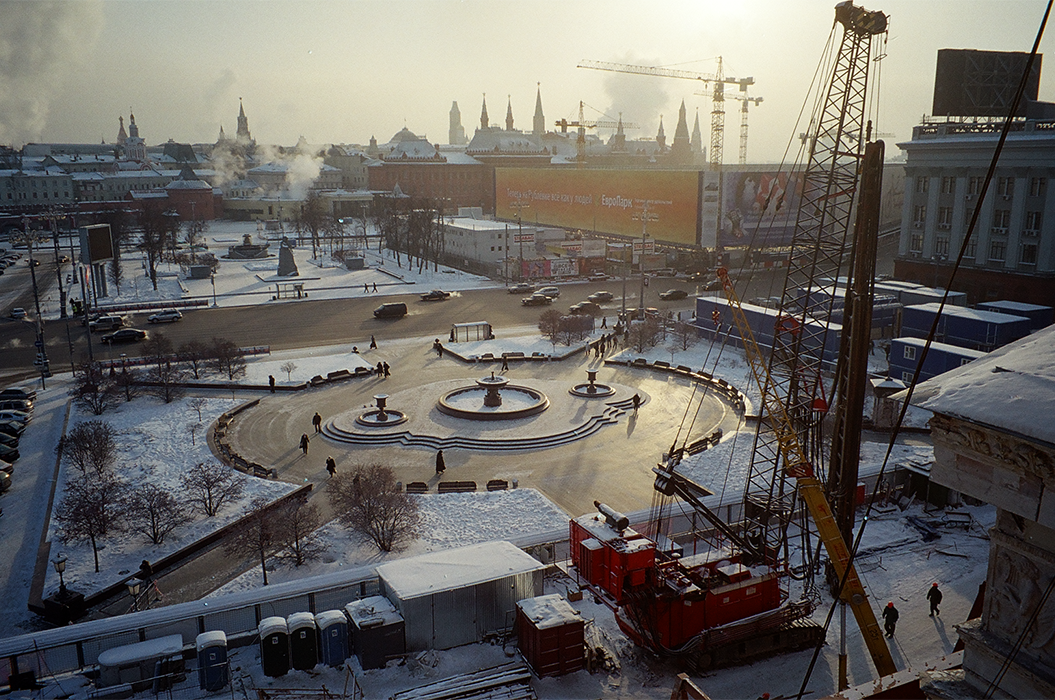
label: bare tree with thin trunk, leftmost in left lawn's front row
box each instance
[55,473,128,573]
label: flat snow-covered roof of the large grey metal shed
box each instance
[378,541,545,600]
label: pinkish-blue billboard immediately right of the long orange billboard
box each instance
[718,171,802,248]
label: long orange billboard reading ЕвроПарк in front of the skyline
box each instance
[495,168,701,246]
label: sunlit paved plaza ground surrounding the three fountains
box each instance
[228,342,735,516]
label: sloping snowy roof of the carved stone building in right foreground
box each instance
[913,322,1055,444]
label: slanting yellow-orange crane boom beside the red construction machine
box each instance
[718,263,897,676]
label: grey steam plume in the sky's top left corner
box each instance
[0,0,102,147]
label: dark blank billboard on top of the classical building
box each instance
[931,48,1043,117]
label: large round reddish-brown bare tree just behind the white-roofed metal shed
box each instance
[327,464,421,551]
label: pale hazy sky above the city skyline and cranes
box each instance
[0,0,1055,162]
